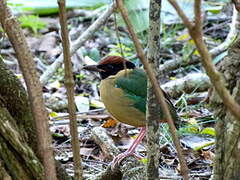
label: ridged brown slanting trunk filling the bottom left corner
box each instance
[0,104,43,180]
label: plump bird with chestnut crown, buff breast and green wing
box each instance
[83,56,179,167]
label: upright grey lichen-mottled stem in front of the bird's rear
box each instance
[146,0,162,179]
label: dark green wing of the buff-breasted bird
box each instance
[115,69,147,113]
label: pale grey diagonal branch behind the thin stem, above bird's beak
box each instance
[40,4,115,84]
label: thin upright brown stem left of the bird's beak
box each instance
[58,0,83,180]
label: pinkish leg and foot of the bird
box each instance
[111,127,146,168]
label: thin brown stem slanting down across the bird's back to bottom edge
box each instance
[117,0,189,180]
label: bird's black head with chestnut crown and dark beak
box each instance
[83,56,135,79]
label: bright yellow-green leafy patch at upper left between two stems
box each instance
[18,15,46,35]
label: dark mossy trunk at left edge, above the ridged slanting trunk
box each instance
[0,59,37,148]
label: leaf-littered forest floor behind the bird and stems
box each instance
[0,2,231,179]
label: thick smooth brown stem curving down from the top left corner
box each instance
[0,0,56,180]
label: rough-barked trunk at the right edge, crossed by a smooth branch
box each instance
[210,39,240,180]
